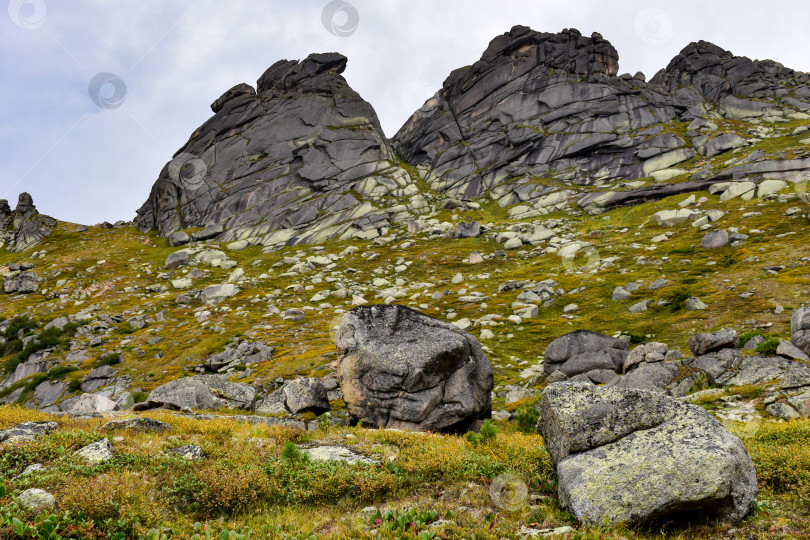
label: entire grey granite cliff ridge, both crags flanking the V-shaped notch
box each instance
[135,26,810,243]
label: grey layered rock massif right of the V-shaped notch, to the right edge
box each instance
[392,26,810,218]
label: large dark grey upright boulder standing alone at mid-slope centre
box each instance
[335,304,494,431]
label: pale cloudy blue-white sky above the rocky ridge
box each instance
[0,0,810,224]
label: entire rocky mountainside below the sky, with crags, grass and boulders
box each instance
[0,27,810,538]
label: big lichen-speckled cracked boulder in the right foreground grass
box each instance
[537,382,758,525]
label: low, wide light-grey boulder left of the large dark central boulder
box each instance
[134,375,256,410]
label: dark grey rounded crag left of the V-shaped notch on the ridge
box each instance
[135,53,427,246]
